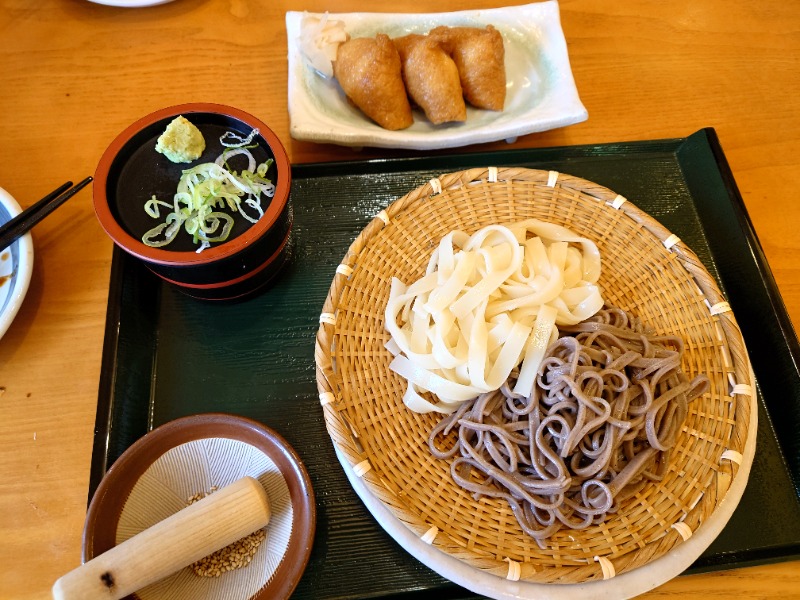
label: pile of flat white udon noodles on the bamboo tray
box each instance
[385,219,603,413]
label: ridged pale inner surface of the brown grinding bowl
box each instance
[117,438,293,600]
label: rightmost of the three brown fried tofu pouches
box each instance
[428,25,506,111]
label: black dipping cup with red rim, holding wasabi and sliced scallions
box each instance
[94,103,292,300]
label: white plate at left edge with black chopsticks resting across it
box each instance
[0,188,33,338]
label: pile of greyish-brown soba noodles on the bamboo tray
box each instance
[428,308,709,545]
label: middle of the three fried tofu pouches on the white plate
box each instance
[392,33,467,125]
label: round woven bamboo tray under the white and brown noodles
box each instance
[315,168,756,584]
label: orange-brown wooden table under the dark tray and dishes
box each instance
[0,0,800,599]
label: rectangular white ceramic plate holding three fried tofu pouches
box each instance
[286,0,588,150]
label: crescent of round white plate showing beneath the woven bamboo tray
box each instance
[336,371,758,600]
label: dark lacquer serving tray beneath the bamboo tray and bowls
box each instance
[89,129,800,600]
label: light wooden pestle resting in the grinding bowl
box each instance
[53,477,270,600]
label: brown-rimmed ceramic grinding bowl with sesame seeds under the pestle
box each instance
[82,413,316,600]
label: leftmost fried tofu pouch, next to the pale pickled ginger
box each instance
[333,33,414,131]
